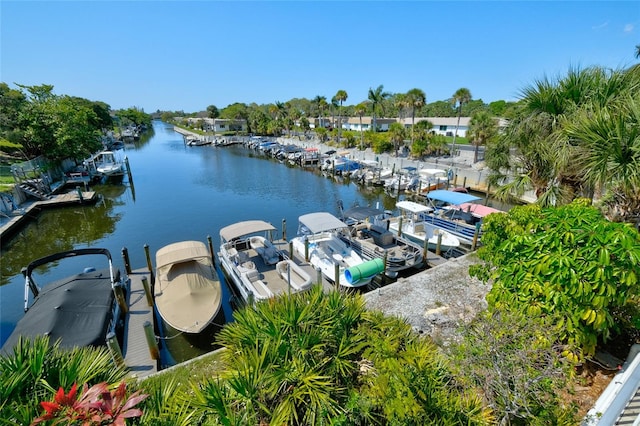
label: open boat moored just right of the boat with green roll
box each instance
[341,207,424,278]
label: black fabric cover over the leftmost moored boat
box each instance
[1,268,116,353]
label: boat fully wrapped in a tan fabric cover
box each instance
[154,241,222,334]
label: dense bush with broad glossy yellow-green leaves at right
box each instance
[470,200,640,356]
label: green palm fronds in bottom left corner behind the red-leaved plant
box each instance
[0,336,126,424]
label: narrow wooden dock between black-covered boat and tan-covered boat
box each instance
[122,269,159,378]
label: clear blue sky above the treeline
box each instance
[0,0,640,112]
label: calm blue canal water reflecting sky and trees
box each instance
[0,121,395,358]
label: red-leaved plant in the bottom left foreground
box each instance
[31,382,148,426]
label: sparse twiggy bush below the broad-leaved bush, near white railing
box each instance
[450,310,578,426]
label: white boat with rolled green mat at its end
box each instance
[291,212,384,287]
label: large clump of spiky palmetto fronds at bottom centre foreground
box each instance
[194,287,490,425]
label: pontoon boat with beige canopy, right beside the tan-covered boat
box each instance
[218,220,312,305]
